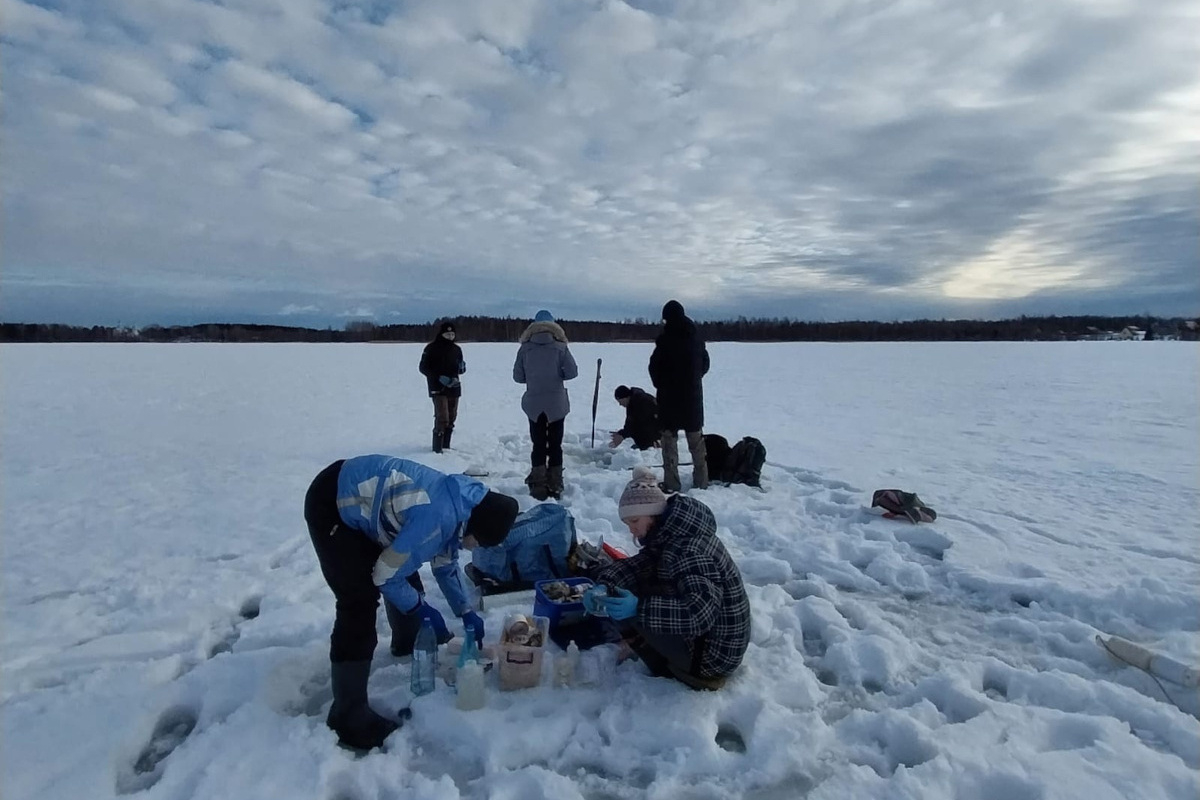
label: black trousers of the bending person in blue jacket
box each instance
[304,461,425,662]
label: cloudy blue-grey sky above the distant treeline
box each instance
[0,0,1200,326]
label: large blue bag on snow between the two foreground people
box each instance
[466,503,576,595]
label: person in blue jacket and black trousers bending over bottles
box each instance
[304,456,518,750]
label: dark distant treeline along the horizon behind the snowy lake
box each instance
[0,315,1198,342]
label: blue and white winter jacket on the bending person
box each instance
[337,456,487,616]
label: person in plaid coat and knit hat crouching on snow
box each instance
[595,467,750,688]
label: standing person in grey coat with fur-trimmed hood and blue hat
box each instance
[512,309,580,500]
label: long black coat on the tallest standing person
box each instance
[650,313,708,431]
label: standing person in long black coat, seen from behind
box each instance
[650,300,708,492]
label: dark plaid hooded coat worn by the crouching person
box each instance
[595,495,750,678]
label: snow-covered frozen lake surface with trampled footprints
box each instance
[0,342,1200,800]
